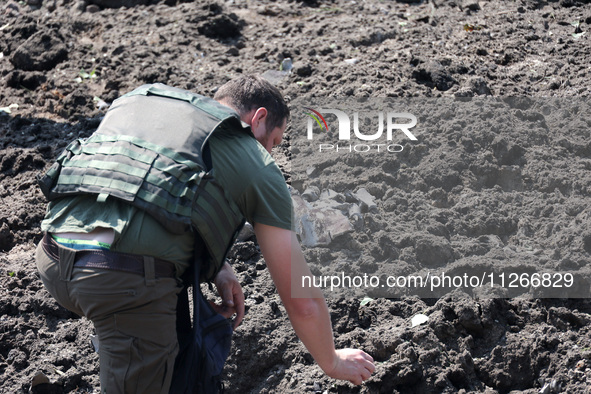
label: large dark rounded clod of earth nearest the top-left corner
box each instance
[10,30,68,71]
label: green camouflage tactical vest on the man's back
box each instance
[39,84,248,280]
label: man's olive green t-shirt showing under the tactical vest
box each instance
[41,130,291,275]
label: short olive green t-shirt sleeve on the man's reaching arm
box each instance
[243,163,292,230]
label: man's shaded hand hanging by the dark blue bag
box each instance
[210,262,244,329]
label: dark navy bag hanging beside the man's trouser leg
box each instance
[169,260,232,394]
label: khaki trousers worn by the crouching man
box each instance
[36,239,182,394]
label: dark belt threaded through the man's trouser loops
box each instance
[41,233,176,278]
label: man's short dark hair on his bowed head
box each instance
[213,75,289,131]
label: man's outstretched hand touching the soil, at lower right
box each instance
[324,349,376,384]
